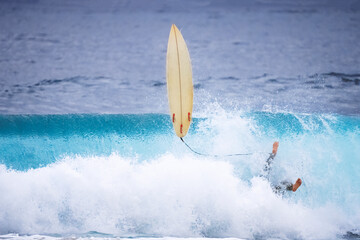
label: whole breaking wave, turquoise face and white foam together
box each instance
[0,111,360,239]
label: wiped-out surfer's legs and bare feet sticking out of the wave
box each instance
[264,142,302,193]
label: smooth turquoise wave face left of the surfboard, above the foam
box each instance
[0,114,172,170]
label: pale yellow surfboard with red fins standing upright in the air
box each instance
[166,24,193,137]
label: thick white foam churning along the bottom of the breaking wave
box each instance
[0,154,349,239]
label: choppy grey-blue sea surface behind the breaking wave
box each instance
[0,0,360,114]
